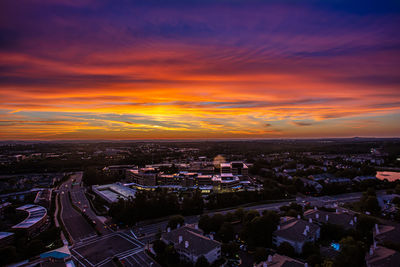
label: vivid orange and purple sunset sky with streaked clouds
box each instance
[0,0,400,140]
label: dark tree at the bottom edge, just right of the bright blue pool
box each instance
[334,237,365,267]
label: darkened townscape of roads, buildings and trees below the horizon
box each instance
[0,138,400,266]
